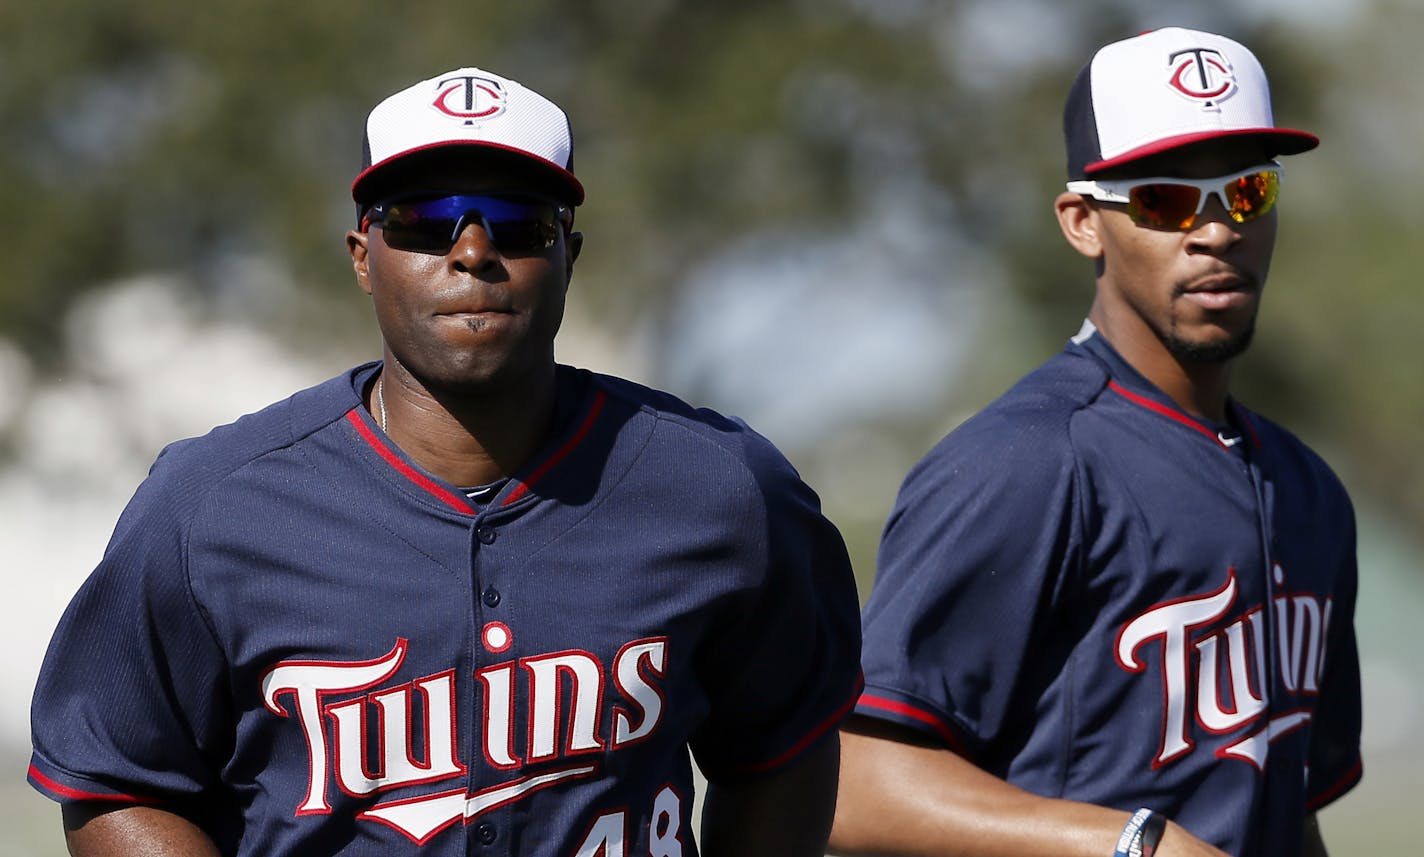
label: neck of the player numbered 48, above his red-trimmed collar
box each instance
[372,363,557,485]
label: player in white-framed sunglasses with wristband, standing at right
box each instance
[832,28,1361,857]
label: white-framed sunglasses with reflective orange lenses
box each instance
[1068,164,1280,229]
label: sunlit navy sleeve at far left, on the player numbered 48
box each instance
[30,461,231,803]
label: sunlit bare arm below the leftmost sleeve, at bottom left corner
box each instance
[63,803,219,857]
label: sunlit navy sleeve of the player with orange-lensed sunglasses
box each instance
[856,414,1081,760]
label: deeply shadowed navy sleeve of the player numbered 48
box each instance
[691,438,860,780]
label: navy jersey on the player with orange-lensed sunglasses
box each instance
[856,326,1361,857]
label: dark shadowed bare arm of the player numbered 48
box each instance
[701,732,840,857]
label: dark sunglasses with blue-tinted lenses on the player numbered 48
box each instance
[363,194,571,255]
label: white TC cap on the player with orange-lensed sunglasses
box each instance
[1064,27,1320,179]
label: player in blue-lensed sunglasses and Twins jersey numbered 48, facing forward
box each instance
[30,68,860,857]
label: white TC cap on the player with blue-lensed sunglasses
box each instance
[352,68,584,205]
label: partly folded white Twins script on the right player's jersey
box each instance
[1116,565,1333,769]
